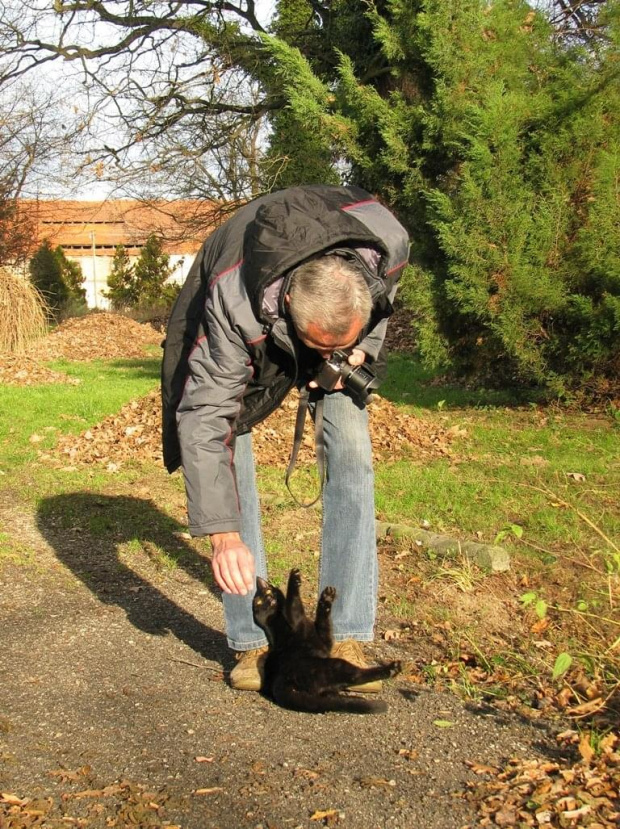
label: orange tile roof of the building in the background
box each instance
[20,199,219,255]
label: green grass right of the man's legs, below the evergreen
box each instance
[376,356,620,549]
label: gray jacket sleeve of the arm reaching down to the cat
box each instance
[177,285,252,536]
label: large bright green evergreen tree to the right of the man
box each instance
[267,0,620,392]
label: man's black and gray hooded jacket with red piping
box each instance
[162,185,408,536]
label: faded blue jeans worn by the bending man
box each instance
[222,392,378,651]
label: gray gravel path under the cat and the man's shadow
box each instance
[0,494,552,829]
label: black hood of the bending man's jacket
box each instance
[242,185,387,322]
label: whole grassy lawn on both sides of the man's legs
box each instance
[0,355,620,694]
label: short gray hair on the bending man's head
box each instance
[288,255,372,337]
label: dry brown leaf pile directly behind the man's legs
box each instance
[45,390,453,470]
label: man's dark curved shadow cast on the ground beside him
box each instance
[37,492,229,663]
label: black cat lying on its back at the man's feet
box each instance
[252,570,401,714]
